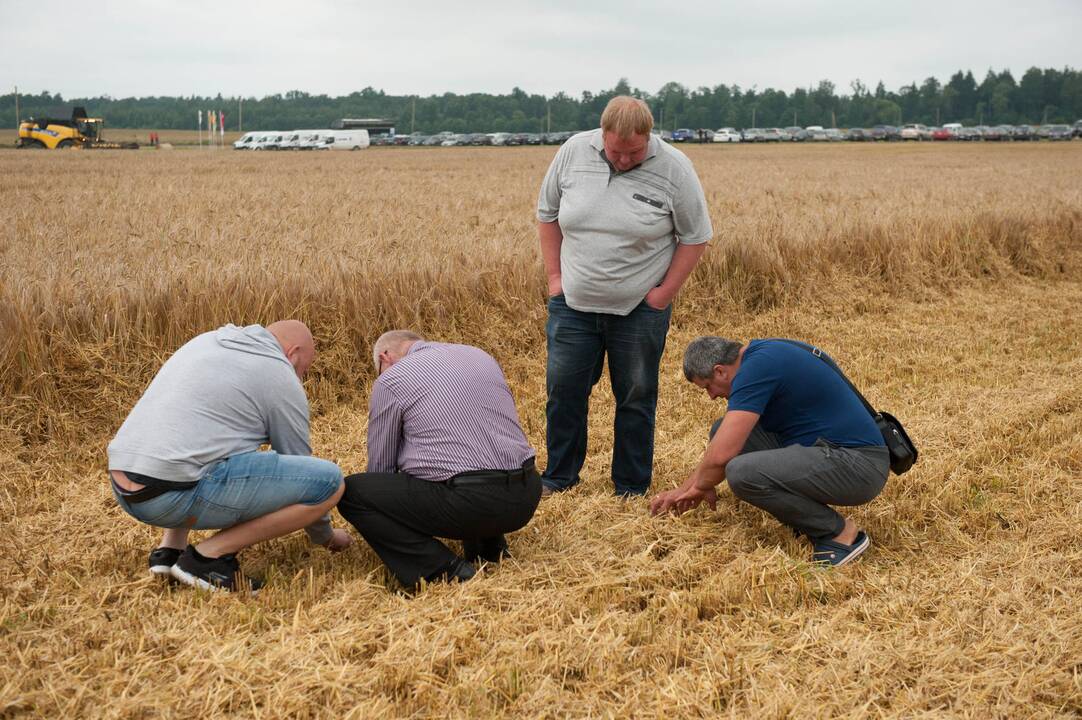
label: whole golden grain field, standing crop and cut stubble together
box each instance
[0,145,1082,718]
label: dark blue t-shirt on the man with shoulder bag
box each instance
[728,340,883,447]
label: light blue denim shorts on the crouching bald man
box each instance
[113,451,342,529]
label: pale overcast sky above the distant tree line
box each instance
[0,0,1082,97]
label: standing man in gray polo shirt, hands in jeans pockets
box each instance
[538,95,713,495]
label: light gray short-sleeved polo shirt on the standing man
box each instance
[538,128,714,315]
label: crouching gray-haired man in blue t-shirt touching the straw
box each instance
[650,336,889,566]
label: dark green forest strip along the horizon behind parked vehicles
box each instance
[0,67,1082,133]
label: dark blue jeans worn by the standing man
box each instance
[541,294,672,495]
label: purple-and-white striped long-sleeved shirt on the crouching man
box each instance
[368,341,533,482]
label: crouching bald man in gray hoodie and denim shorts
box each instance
[108,320,352,590]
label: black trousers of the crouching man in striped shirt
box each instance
[338,462,541,587]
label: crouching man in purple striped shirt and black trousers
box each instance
[339,330,541,587]
